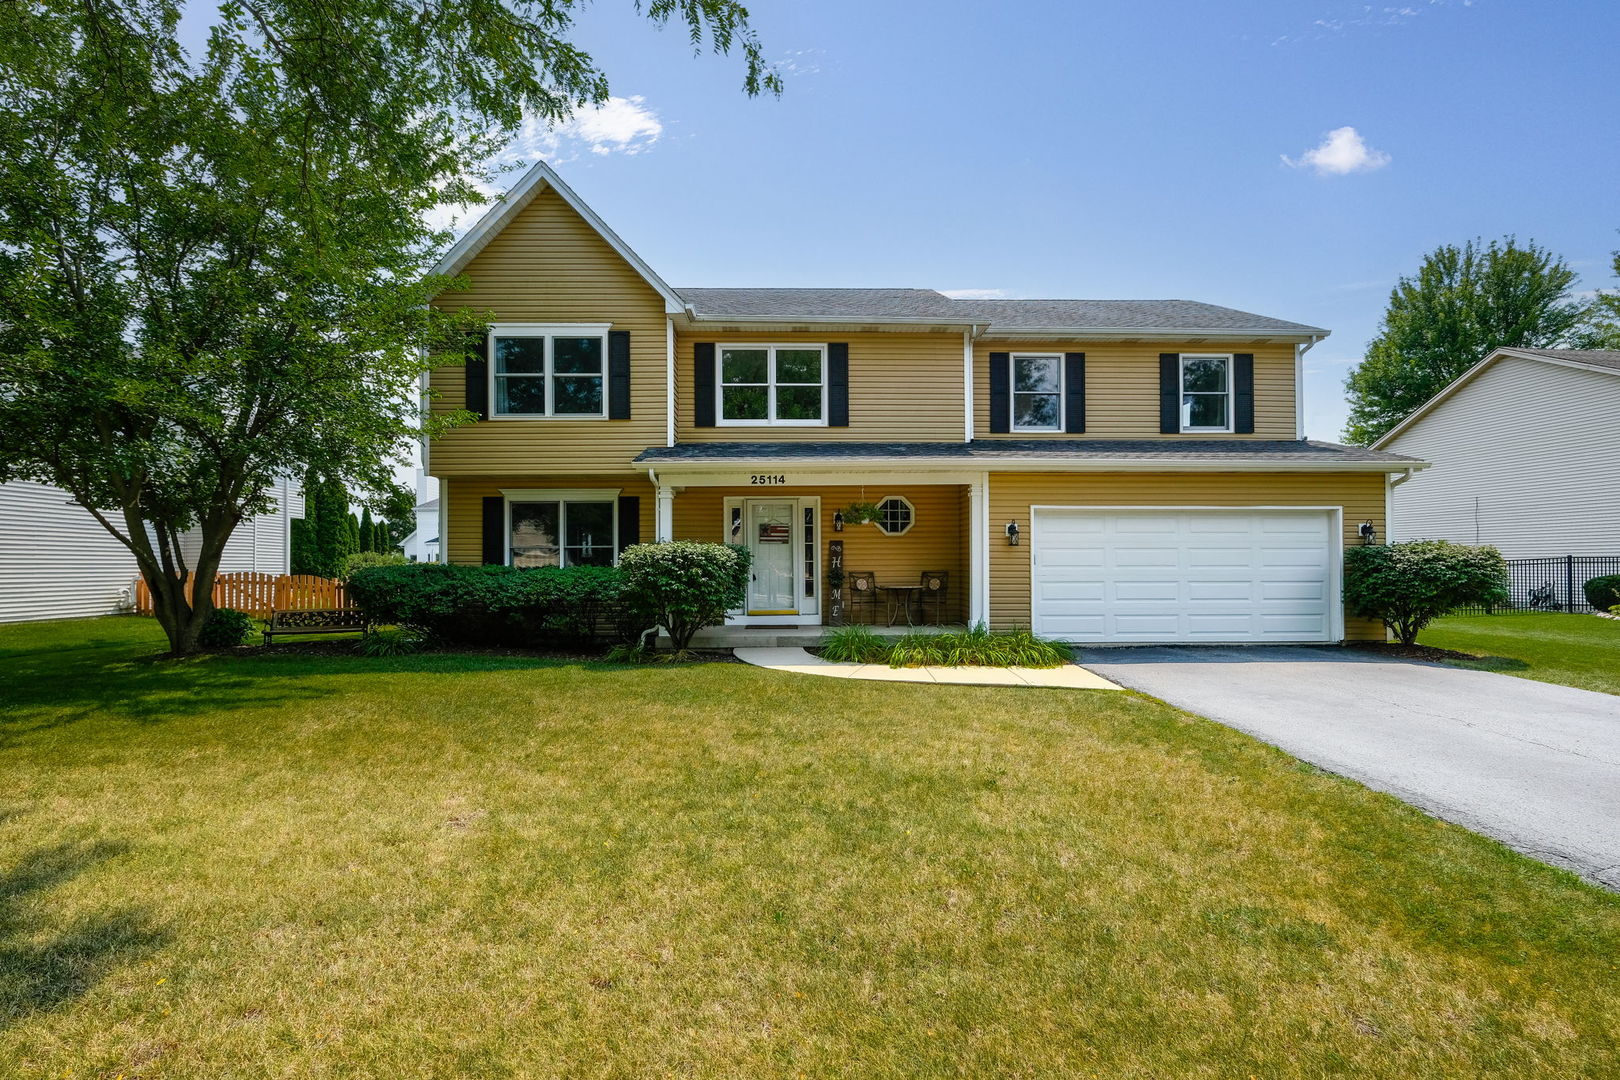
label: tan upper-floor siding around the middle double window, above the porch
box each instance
[676,329,966,442]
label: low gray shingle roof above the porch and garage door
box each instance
[635,439,1418,465]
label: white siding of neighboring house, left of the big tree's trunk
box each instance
[0,481,138,622]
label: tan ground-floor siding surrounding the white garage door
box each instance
[990,473,1385,641]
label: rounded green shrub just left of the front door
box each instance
[619,541,750,654]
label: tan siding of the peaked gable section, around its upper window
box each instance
[429,189,667,476]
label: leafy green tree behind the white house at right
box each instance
[1345,236,1588,444]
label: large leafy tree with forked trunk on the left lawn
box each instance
[0,0,778,654]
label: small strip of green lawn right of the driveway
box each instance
[1418,612,1620,693]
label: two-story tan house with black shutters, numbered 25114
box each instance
[426,164,1422,641]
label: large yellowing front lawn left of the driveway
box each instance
[9,619,1620,1080]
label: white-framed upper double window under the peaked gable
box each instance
[489,324,608,419]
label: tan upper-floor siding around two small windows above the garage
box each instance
[974,338,1298,439]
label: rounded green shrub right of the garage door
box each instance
[1345,541,1508,644]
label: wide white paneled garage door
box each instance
[1030,508,1340,641]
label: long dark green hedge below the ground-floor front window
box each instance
[348,562,640,646]
